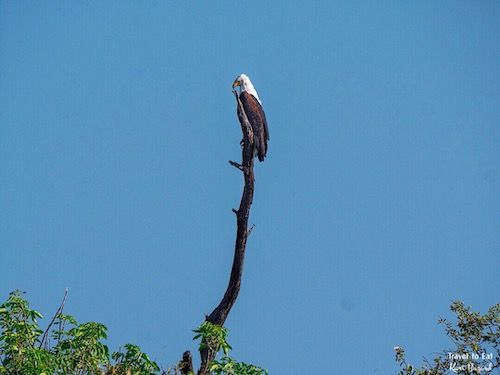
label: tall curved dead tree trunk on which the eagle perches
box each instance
[198,90,255,375]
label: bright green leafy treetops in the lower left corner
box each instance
[0,291,160,375]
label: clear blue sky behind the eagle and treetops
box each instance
[0,1,500,374]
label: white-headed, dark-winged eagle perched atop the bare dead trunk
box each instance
[233,74,269,161]
